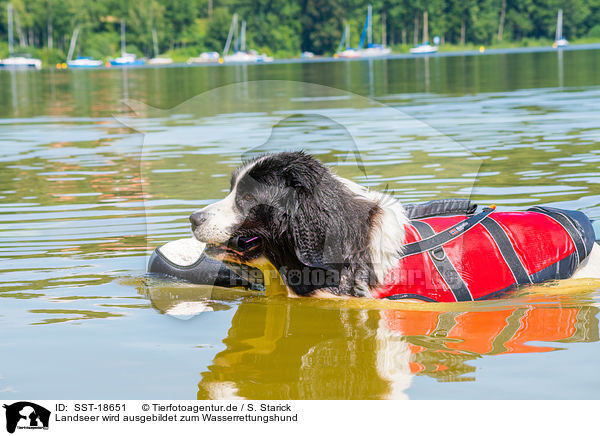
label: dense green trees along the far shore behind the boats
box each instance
[0,0,600,59]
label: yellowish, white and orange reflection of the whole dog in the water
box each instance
[198,300,598,399]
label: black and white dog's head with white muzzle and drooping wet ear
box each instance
[190,152,379,294]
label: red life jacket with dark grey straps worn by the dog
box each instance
[375,207,595,302]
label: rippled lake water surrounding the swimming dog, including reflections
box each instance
[0,50,600,399]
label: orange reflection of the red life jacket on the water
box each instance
[383,306,600,381]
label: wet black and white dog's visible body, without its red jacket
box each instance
[190,152,600,297]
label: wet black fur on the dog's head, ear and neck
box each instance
[232,152,380,296]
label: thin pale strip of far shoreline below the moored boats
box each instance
[0,43,600,71]
